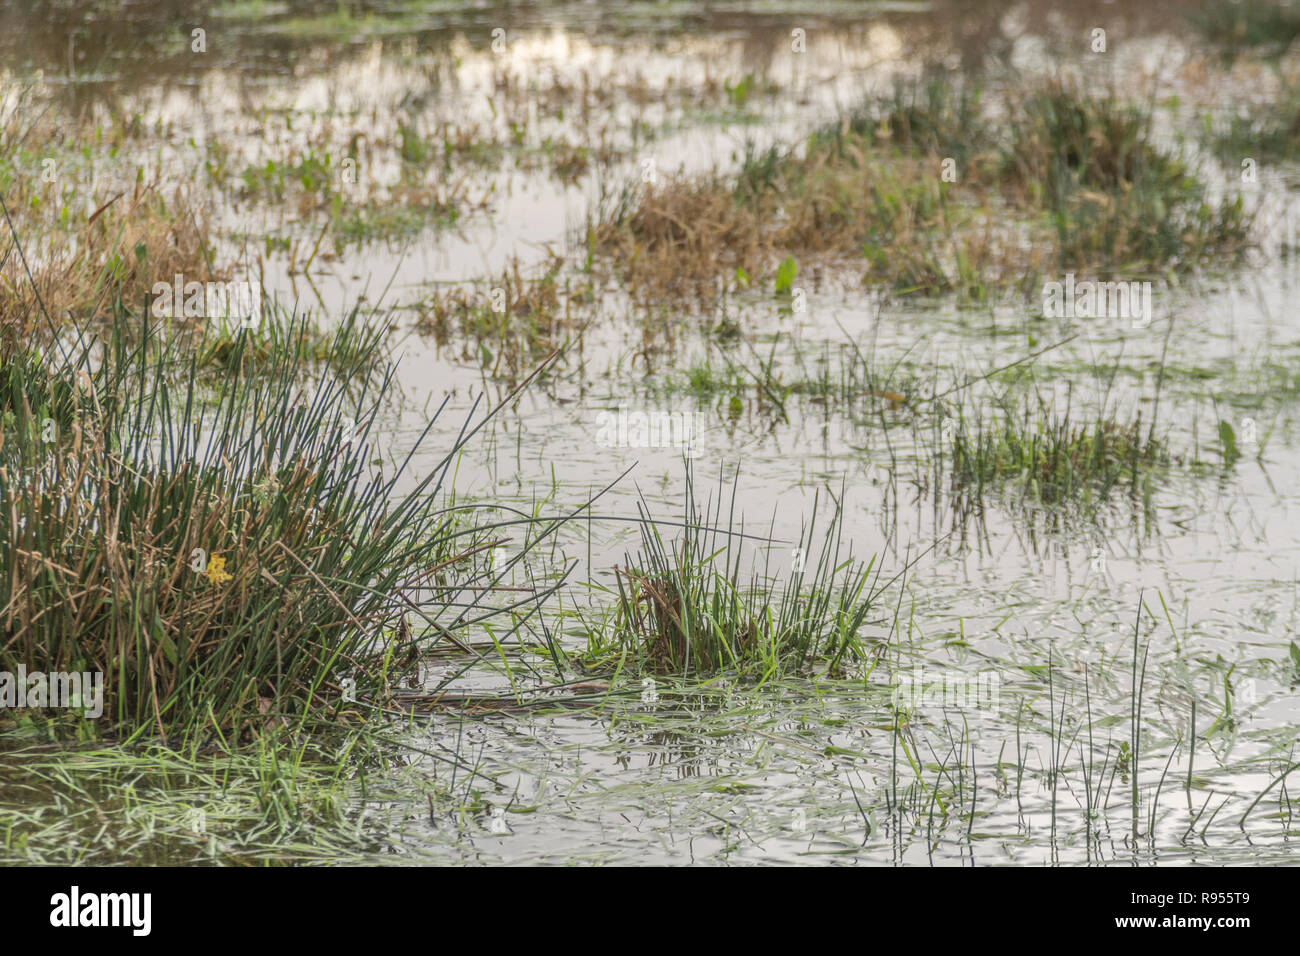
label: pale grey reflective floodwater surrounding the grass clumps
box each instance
[0,3,1300,864]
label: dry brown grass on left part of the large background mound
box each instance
[589,149,1023,299]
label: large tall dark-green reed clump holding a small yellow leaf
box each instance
[0,299,546,736]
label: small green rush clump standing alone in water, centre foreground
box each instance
[586,476,881,679]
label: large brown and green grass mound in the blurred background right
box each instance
[588,78,1251,310]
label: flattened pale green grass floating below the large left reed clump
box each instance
[0,724,491,866]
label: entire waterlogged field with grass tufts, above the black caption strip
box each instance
[0,0,1300,865]
